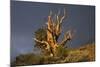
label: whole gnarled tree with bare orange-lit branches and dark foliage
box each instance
[34,9,72,56]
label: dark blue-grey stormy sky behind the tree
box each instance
[11,1,95,58]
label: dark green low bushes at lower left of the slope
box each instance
[12,54,43,66]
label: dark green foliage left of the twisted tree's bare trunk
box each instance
[35,28,47,53]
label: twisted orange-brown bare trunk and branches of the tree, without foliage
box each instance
[34,10,72,56]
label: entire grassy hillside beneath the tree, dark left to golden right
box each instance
[12,44,95,66]
